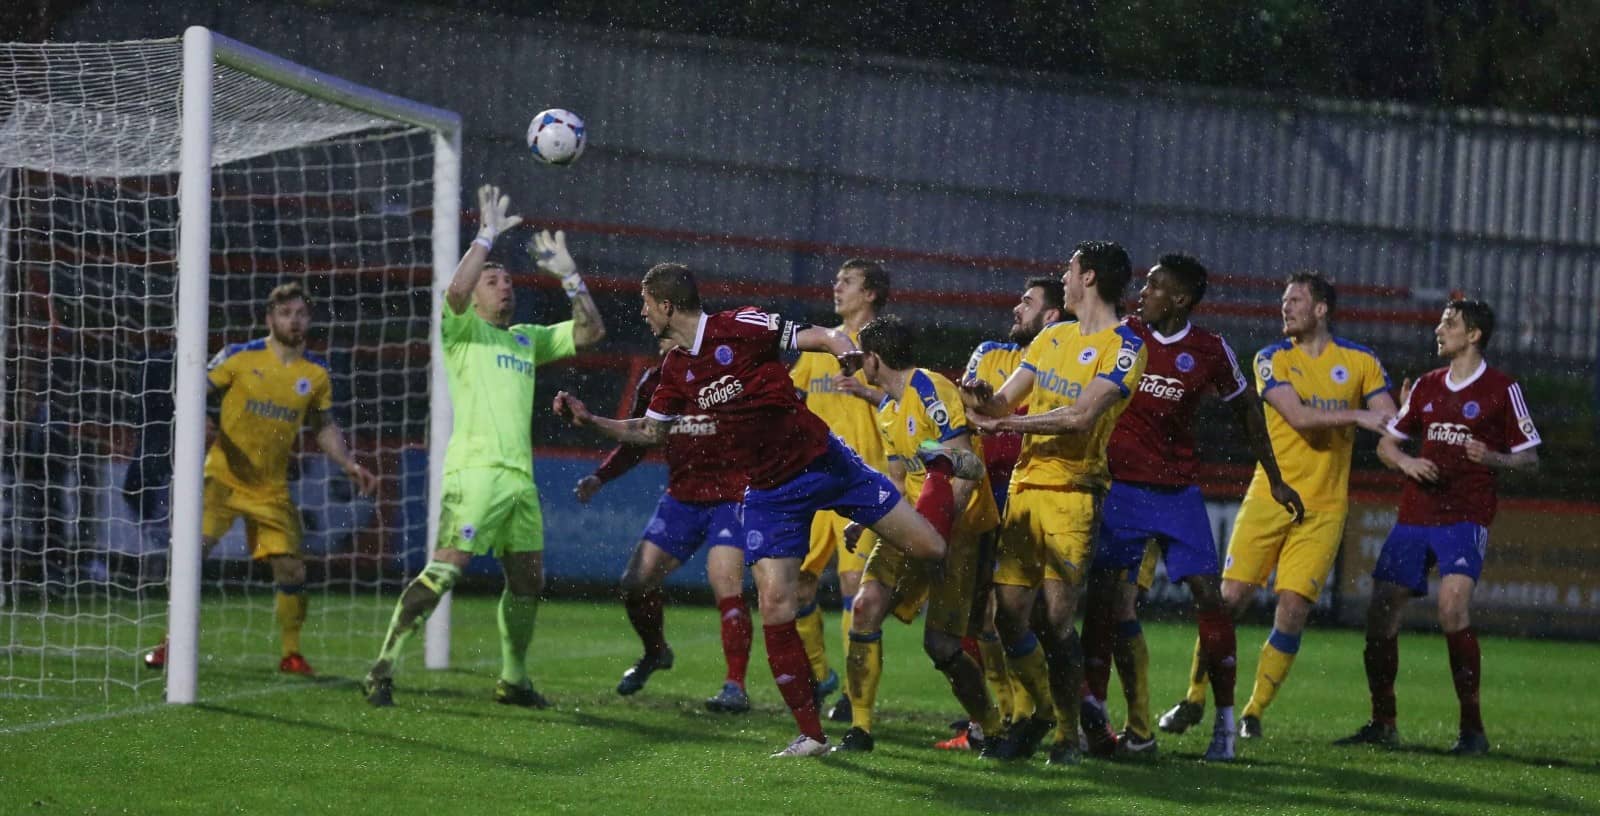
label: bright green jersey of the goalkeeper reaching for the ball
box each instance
[440,302,578,478]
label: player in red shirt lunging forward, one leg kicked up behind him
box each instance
[554,264,954,757]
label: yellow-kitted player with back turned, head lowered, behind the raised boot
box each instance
[834,317,1000,750]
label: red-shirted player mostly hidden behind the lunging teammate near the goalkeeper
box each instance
[573,339,752,714]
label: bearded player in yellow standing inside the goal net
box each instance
[144,283,378,675]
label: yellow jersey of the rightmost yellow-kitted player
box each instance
[1245,338,1389,510]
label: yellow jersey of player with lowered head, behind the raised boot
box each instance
[878,368,1000,533]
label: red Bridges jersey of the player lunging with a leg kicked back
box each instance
[645,306,829,490]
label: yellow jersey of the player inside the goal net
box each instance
[205,338,333,493]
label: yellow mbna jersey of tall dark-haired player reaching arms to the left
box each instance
[1011,322,1147,493]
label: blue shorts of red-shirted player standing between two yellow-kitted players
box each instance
[1091,482,1222,584]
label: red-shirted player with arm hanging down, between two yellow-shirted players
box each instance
[1083,254,1306,762]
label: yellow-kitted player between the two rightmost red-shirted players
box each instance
[1158,272,1395,739]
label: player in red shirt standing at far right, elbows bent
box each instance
[1336,301,1539,755]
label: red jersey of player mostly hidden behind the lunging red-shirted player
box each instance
[595,366,746,502]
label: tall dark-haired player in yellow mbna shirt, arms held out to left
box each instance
[962,242,1146,765]
